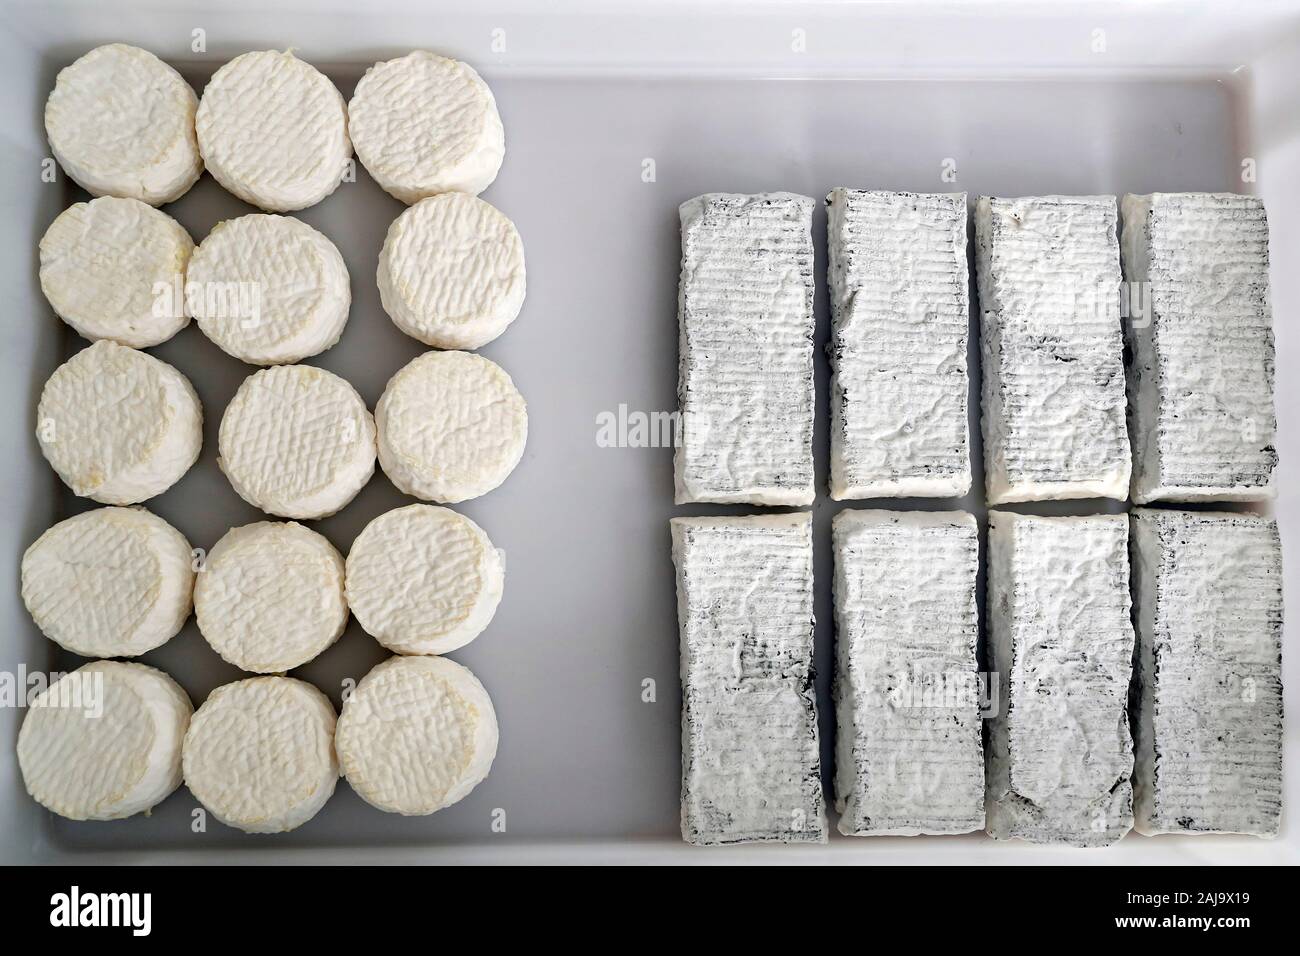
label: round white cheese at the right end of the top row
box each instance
[348,49,506,203]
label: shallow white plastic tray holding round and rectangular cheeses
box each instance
[0,0,1300,864]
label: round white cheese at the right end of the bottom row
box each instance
[338,657,498,817]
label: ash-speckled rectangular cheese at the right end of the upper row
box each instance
[1121,193,1278,503]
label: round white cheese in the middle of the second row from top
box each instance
[186,213,352,365]
